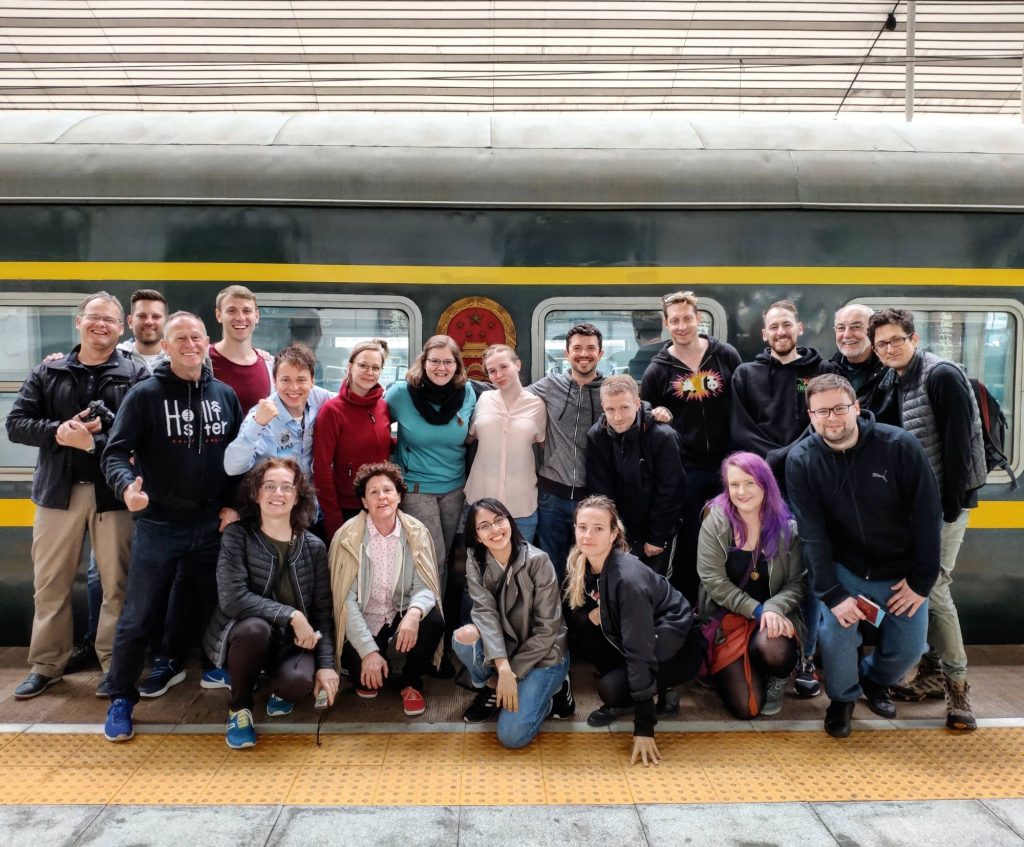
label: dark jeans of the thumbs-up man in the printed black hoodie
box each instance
[108,517,220,703]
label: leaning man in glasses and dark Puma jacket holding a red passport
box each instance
[785,374,942,738]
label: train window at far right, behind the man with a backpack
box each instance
[861,298,1024,471]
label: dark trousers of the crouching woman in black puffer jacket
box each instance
[225,618,316,712]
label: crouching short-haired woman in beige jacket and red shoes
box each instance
[330,462,444,716]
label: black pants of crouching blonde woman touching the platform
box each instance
[569,608,706,707]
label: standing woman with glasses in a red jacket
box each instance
[313,338,393,543]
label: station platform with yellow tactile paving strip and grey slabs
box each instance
[0,646,1024,846]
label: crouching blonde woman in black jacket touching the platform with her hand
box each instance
[565,496,705,765]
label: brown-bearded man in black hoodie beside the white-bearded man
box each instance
[730,300,835,457]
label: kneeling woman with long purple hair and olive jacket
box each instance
[697,453,805,720]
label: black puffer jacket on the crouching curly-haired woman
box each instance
[203,521,335,670]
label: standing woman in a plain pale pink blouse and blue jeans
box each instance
[466,344,548,544]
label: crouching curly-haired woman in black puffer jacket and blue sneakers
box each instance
[204,459,339,749]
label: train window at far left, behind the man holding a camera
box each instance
[0,293,82,471]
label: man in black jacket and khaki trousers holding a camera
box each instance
[7,291,148,700]
